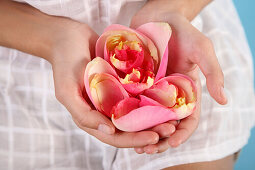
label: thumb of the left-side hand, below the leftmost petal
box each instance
[56,80,115,134]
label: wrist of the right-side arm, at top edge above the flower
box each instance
[130,0,211,28]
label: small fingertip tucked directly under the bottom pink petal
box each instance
[151,122,175,138]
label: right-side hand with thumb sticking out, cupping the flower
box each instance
[131,6,227,153]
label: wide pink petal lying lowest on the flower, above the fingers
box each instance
[112,95,196,132]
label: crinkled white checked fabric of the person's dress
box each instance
[0,0,255,170]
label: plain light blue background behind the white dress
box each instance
[233,0,255,170]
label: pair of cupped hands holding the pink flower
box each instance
[49,7,227,154]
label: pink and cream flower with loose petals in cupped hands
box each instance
[84,23,196,132]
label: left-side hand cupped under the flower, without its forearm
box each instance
[47,19,163,148]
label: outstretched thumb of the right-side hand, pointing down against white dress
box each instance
[195,39,227,104]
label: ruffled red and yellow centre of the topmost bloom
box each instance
[106,34,155,90]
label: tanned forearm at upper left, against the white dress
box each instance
[0,0,80,60]
